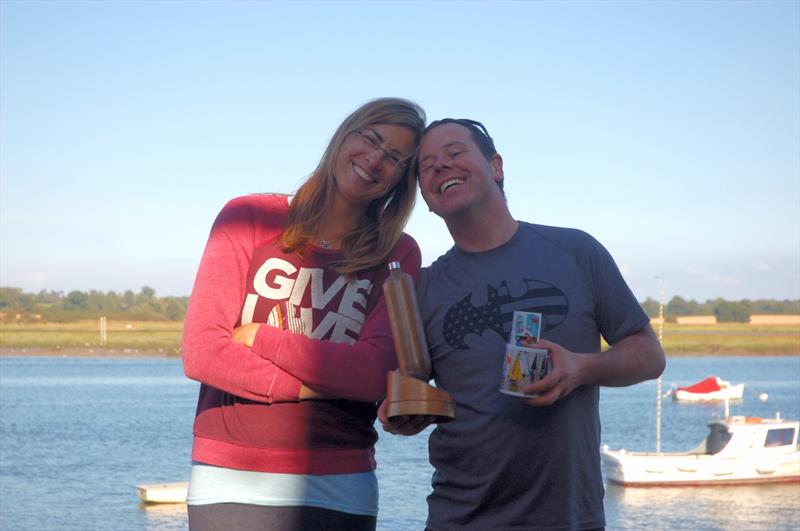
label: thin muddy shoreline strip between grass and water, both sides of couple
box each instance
[0,347,800,359]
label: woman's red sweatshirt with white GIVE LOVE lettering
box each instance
[183,195,421,474]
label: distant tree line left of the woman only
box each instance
[0,286,189,321]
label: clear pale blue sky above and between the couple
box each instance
[0,0,800,301]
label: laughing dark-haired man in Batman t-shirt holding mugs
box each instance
[379,119,665,531]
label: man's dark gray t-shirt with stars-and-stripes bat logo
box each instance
[417,220,648,531]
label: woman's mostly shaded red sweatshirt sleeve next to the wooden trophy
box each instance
[253,235,422,402]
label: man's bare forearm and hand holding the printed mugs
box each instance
[524,324,666,406]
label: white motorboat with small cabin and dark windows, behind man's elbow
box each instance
[601,416,800,487]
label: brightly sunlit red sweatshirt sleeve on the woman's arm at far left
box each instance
[182,196,301,403]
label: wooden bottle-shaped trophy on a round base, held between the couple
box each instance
[383,262,455,422]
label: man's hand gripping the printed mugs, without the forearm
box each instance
[522,339,593,406]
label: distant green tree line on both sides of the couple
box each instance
[0,286,800,322]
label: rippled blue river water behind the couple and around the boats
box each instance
[0,357,800,531]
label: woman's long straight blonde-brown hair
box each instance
[280,98,425,275]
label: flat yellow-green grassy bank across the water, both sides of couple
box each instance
[0,320,800,356]
